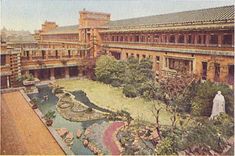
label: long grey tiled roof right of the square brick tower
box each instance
[106,5,234,29]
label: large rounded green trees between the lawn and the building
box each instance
[95,56,159,99]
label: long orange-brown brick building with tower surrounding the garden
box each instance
[1,6,234,89]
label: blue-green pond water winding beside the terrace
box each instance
[28,85,106,155]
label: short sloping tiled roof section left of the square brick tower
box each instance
[42,25,78,34]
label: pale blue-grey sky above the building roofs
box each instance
[0,0,234,33]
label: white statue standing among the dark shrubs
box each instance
[210,91,225,119]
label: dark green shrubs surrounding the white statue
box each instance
[173,81,234,116]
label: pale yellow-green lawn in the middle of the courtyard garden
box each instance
[56,79,171,125]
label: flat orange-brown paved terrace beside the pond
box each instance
[0,91,64,155]
